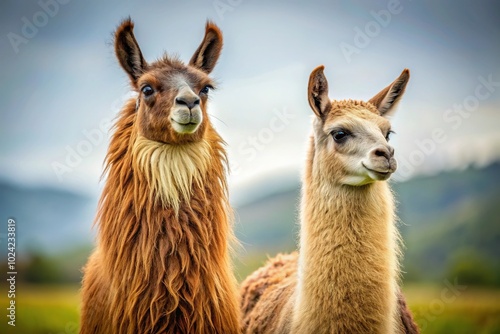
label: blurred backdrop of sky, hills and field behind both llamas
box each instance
[0,0,500,333]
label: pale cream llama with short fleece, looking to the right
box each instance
[241,66,418,334]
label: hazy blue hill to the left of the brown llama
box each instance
[0,181,97,256]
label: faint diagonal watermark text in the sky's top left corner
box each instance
[7,0,71,54]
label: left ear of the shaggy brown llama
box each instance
[115,17,147,84]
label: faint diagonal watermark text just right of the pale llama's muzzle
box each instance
[394,74,500,181]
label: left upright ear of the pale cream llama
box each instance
[307,65,331,118]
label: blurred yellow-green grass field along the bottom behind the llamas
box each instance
[0,282,500,334]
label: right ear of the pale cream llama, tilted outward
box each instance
[368,68,410,117]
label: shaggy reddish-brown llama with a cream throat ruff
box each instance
[80,19,240,334]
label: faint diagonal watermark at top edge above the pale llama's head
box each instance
[339,0,411,64]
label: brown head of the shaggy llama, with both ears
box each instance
[115,19,222,144]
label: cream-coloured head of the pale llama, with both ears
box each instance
[308,66,410,186]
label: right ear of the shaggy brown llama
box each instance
[189,21,222,74]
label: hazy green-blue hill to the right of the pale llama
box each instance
[395,163,500,284]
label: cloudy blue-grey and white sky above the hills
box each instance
[0,0,500,198]
